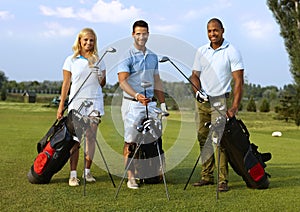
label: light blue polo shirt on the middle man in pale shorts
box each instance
[118,46,159,98]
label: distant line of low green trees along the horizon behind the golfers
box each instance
[0,71,300,126]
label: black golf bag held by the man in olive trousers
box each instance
[221,117,271,189]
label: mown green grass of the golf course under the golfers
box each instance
[0,102,300,211]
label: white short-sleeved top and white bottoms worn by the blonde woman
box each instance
[63,55,106,115]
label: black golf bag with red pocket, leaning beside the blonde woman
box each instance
[27,110,89,184]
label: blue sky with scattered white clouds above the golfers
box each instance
[0,0,293,87]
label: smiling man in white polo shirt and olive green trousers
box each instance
[191,18,244,191]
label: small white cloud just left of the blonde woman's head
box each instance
[41,22,76,38]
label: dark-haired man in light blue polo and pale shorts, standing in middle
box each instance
[118,20,166,189]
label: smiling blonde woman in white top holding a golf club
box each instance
[57,28,106,186]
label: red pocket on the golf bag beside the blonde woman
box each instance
[33,142,55,175]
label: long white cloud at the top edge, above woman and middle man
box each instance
[40,0,141,23]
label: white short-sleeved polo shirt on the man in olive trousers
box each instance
[193,40,244,96]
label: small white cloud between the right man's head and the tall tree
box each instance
[242,20,274,39]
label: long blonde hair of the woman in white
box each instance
[72,28,99,65]
